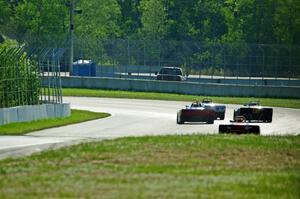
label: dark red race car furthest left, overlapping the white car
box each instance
[177,102,217,124]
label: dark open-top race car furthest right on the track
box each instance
[233,101,273,122]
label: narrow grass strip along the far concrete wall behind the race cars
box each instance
[63,88,300,109]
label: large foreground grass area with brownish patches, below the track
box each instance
[0,135,300,199]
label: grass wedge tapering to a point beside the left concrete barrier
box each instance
[0,110,109,135]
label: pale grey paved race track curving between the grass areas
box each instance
[0,97,300,158]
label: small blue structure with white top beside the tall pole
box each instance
[71,60,96,77]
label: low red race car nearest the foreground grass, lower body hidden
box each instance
[219,116,260,134]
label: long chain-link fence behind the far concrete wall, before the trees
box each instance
[64,38,300,79]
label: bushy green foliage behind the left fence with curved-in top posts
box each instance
[0,41,40,108]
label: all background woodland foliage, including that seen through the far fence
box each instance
[0,0,300,85]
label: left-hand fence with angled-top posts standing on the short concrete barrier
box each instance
[0,45,64,108]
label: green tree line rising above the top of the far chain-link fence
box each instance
[0,0,300,45]
